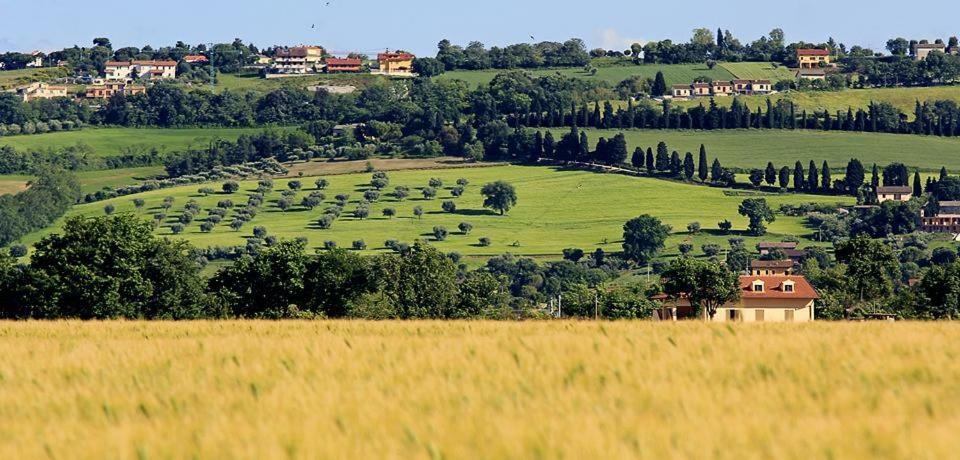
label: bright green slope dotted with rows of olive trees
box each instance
[18,166,852,256]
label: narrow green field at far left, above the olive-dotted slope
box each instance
[0,128,276,157]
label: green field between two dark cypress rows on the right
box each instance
[553,128,960,172]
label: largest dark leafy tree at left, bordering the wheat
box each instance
[29,215,212,319]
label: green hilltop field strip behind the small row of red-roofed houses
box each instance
[437,64,734,86]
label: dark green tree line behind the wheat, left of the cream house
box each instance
[0,215,652,319]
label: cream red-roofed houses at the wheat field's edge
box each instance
[652,242,819,323]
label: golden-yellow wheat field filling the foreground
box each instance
[0,322,960,459]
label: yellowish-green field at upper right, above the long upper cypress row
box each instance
[674,85,960,119]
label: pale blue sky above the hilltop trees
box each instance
[0,0,960,56]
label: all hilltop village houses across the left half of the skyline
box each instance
[7,45,416,102]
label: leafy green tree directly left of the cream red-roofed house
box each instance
[663,257,740,319]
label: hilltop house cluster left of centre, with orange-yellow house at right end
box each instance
[266,45,416,77]
